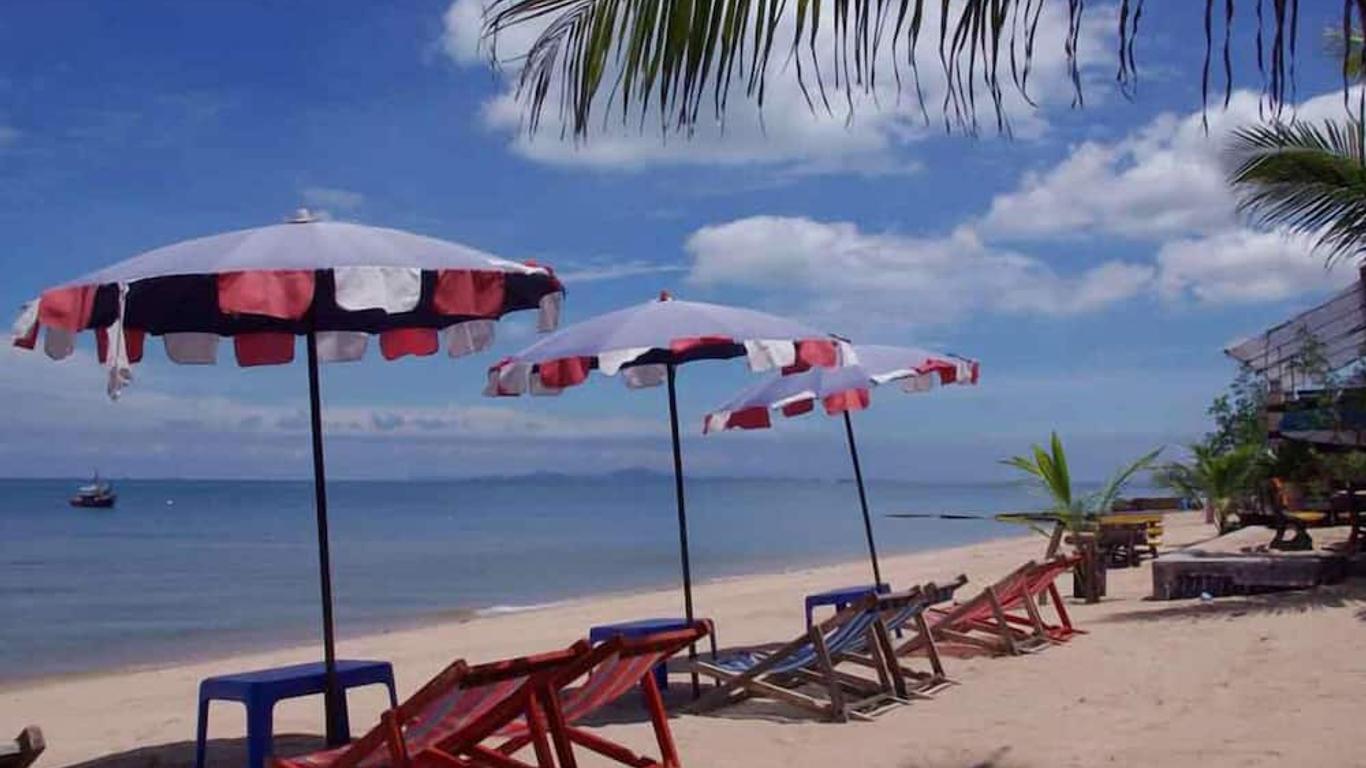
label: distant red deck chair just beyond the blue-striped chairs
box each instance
[896,562,1048,656]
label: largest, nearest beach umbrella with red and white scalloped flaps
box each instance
[14,210,564,743]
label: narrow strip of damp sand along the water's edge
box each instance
[0,523,1033,694]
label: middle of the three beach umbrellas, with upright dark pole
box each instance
[484,292,847,642]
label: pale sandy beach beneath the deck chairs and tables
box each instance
[0,514,1366,768]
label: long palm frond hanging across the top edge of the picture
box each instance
[485,0,1366,137]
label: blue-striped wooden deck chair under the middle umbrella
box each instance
[688,593,914,723]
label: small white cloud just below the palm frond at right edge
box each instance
[1157,230,1355,303]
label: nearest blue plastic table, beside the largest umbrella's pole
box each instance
[194,660,399,768]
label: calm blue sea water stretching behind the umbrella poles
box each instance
[0,474,1092,682]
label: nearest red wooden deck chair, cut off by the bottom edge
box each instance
[272,641,590,768]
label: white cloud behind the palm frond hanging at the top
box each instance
[443,0,1113,175]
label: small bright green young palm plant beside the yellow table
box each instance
[1001,432,1162,558]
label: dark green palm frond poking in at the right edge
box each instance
[1229,122,1366,264]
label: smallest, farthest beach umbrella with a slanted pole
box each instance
[702,344,979,584]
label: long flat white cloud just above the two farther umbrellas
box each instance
[686,216,1154,324]
